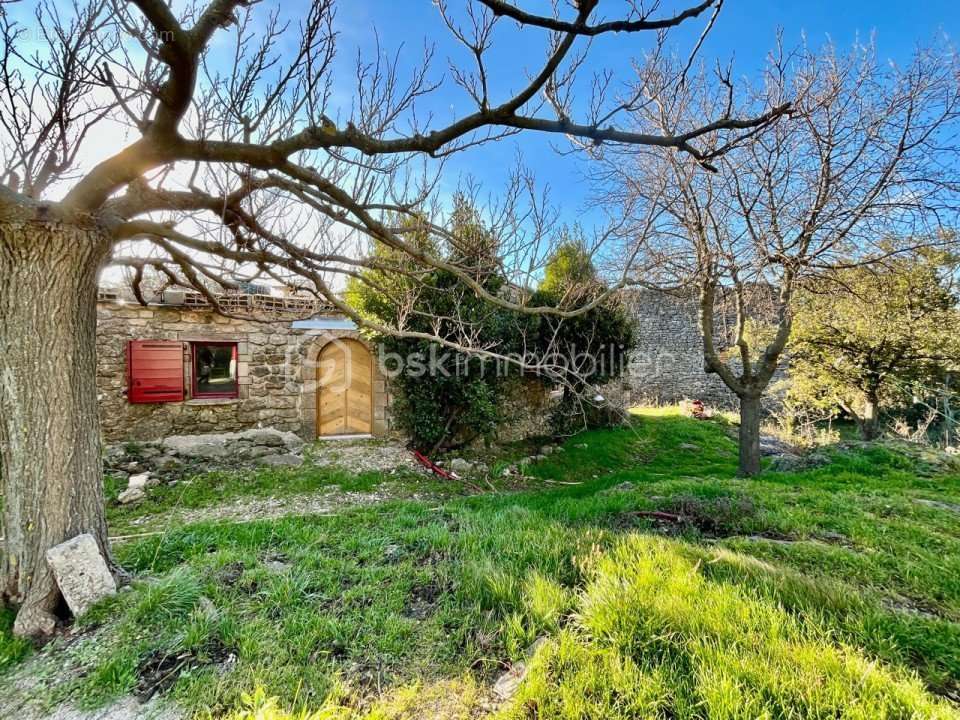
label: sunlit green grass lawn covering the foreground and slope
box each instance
[0,410,960,720]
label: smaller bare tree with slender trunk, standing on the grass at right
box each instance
[597,42,960,475]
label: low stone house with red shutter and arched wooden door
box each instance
[97,292,389,441]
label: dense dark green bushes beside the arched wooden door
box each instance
[347,205,632,452]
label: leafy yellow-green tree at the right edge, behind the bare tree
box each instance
[787,252,960,440]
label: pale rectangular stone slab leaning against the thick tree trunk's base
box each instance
[47,533,117,617]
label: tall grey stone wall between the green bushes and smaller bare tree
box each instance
[606,290,736,407]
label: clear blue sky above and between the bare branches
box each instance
[326,0,960,231]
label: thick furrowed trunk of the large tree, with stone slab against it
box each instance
[0,221,110,636]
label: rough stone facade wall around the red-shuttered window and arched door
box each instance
[97,302,389,441]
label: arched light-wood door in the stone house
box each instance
[317,340,373,437]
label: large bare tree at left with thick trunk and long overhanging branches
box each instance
[0,0,785,635]
